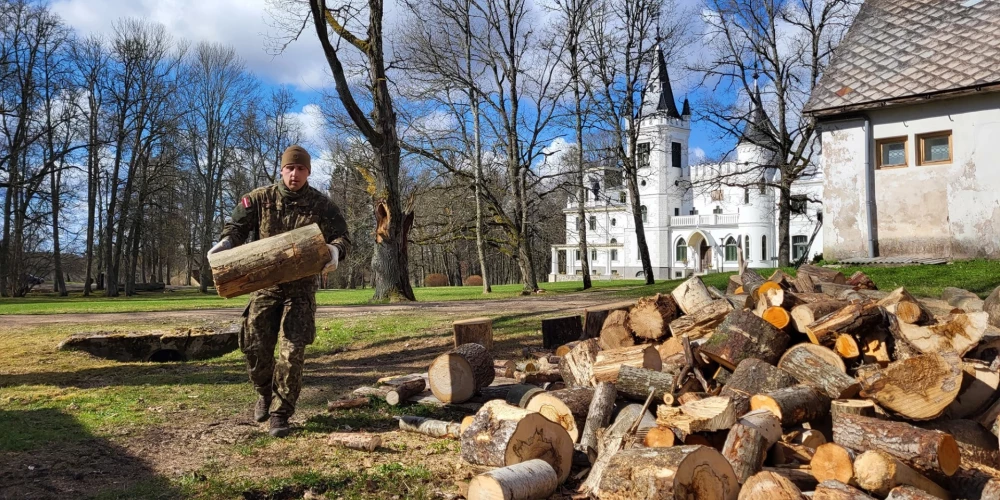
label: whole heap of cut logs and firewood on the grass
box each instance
[346,265,1000,500]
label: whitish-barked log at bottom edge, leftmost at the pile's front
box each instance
[465,458,559,500]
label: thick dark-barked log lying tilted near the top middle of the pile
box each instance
[700,311,788,370]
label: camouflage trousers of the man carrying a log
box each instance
[239,290,316,417]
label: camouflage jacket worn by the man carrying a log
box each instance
[222,180,351,295]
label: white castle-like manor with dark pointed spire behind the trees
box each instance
[549,52,823,281]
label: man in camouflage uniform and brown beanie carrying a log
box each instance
[209,146,351,437]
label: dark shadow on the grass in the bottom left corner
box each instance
[0,409,183,498]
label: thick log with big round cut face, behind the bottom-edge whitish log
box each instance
[462,400,573,483]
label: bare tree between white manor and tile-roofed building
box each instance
[693,0,860,266]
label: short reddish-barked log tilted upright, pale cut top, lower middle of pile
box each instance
[722,410,781,483]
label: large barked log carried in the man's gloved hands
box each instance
[210,224,330,298]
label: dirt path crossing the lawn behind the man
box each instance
[0,292,618,328]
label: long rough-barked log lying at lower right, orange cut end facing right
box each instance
[833,414,961,475]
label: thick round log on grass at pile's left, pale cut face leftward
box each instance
[427,344,496,403]
